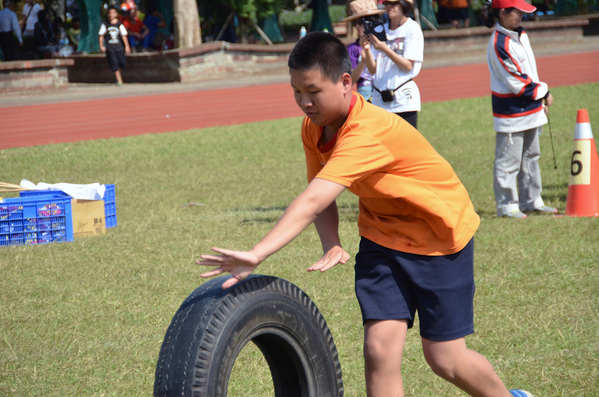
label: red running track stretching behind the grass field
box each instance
[0,52,599,149]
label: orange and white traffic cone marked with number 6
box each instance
[566,109,599,216]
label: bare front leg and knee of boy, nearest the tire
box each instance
[364,320,408,397]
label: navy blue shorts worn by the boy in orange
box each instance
[355,238,474,341]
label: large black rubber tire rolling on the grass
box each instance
[154,275,343,397]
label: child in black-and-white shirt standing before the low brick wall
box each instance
[98,7,131,85]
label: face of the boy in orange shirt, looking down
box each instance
[289,68,352,129]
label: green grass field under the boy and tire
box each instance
[0,84,599,397]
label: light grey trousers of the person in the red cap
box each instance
[493,127,545,216]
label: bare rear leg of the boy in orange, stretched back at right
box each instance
[422,338,511,397]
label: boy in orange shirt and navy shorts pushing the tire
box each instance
[197,32,530,397]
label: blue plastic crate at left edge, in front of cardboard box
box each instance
[0,195,74,247]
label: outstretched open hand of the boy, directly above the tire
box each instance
[196,247,261,289]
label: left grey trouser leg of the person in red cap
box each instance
[493,132,523,216]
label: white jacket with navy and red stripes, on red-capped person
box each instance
[487,24,549,133]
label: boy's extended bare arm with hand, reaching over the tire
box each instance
[196,178,345,288]
